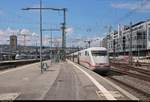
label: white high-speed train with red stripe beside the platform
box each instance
[68,47,110,72]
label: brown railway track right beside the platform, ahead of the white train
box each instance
[106,69,150,99]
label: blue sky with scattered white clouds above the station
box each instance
[0,0,150,46]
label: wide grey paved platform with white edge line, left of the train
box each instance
[0,60,139,100]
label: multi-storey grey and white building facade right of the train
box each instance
[102,20,150,56]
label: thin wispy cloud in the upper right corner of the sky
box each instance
[111,0,150,12]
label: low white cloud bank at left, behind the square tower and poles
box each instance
[0,27,62,46]
